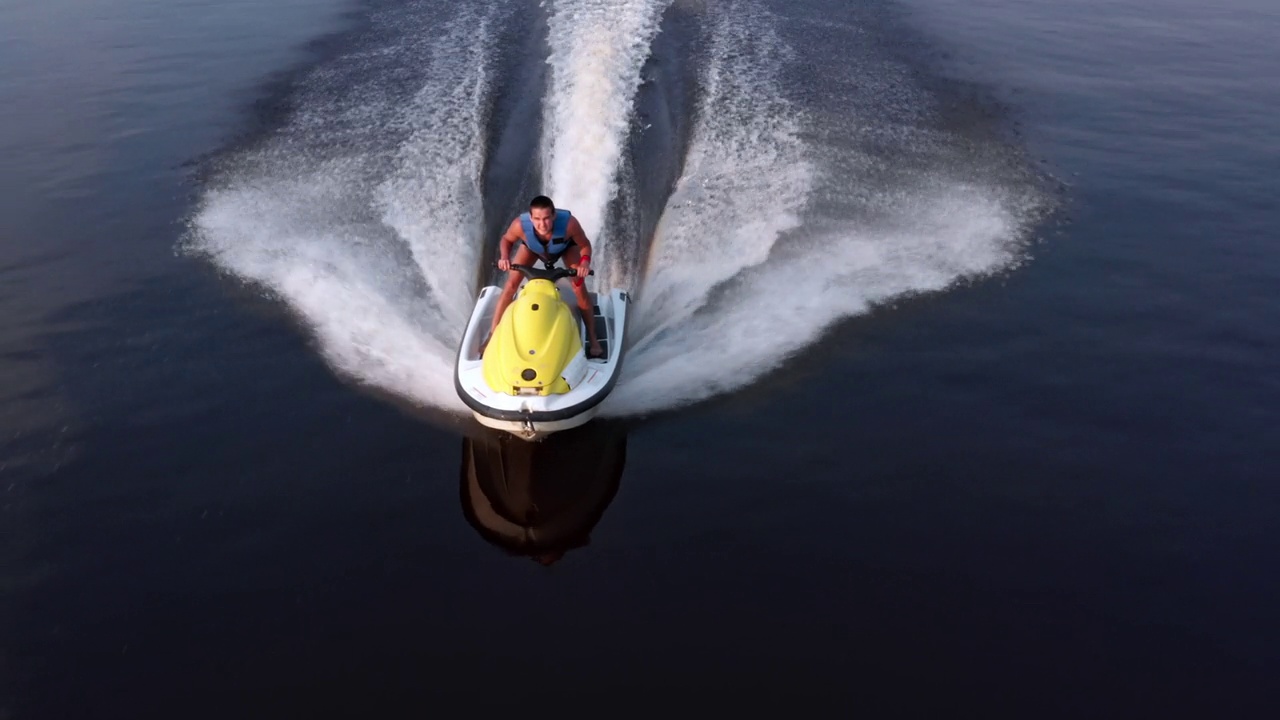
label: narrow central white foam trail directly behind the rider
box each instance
[543,0,671,288]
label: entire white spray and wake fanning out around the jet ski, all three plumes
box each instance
[188,0,1037,415]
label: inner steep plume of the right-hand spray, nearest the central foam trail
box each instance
[616,4,815,366]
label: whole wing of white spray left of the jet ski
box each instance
[188,4,492,410]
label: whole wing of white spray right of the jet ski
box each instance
[602,3,1044,416]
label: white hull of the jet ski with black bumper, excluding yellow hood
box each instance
[453,286,631,441]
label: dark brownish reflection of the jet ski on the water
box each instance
[460,420,627,565]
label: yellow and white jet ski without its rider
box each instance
[453,260,631,441]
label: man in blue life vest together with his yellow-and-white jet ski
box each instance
[454,196,630,439]
